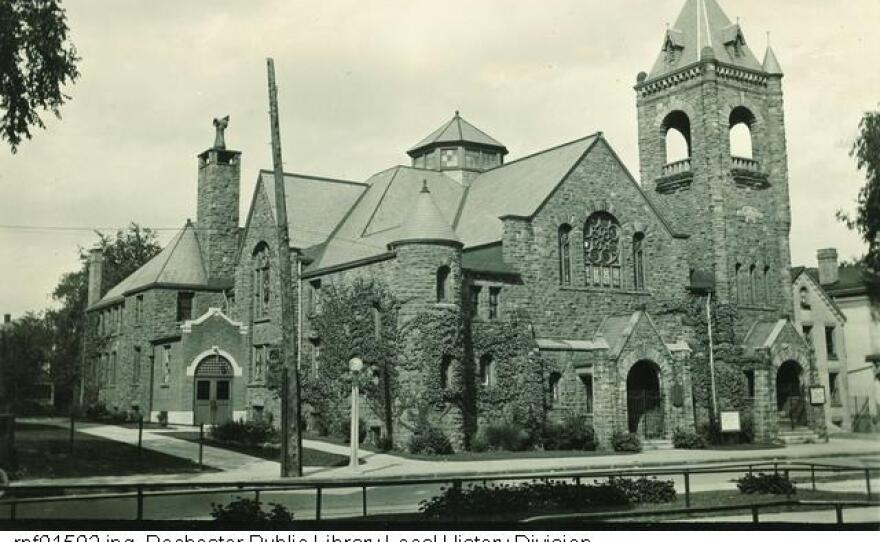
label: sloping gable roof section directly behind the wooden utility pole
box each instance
[255,170,367,249]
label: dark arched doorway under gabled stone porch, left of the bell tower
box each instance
[626,360,666,439]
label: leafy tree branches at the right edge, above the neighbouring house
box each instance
[837,111,880,302]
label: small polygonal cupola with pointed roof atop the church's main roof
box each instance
[407,111,507,184]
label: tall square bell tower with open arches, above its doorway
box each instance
[635,0,792,321]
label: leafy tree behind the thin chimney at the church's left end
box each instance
[46,223,161,406]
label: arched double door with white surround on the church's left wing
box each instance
[193,354,233,425]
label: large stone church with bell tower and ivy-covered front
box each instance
[82,0,825,445]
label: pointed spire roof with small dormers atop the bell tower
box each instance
[648,0,762,80]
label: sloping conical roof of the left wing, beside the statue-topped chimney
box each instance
[89,221,213,309]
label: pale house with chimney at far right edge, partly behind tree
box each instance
[814,248,880,431]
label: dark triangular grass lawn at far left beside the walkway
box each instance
[12,422,215,480]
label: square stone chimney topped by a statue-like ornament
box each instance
[196,116,241,280]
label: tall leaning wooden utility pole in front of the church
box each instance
[266,58,302,477]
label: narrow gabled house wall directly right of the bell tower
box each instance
[791,267,852,431]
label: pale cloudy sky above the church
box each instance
[0,0,880,316]
